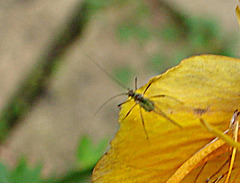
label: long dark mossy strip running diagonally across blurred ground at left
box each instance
[0,1,90,142]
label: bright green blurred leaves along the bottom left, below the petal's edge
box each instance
[0,136,109,183]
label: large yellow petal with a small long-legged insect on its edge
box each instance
[92,55,240,183]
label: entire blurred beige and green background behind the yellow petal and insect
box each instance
[0,0,239,183]
